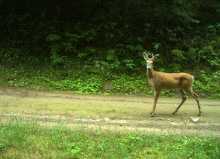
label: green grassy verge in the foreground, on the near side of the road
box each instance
[0,116,220,159]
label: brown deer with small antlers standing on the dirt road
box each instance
[143,52,202,117]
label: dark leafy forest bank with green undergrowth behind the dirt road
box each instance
[0,0,220,98]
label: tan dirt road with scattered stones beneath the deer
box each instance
[0,87,220,138]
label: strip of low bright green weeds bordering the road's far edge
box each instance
[0,66,220,98]
